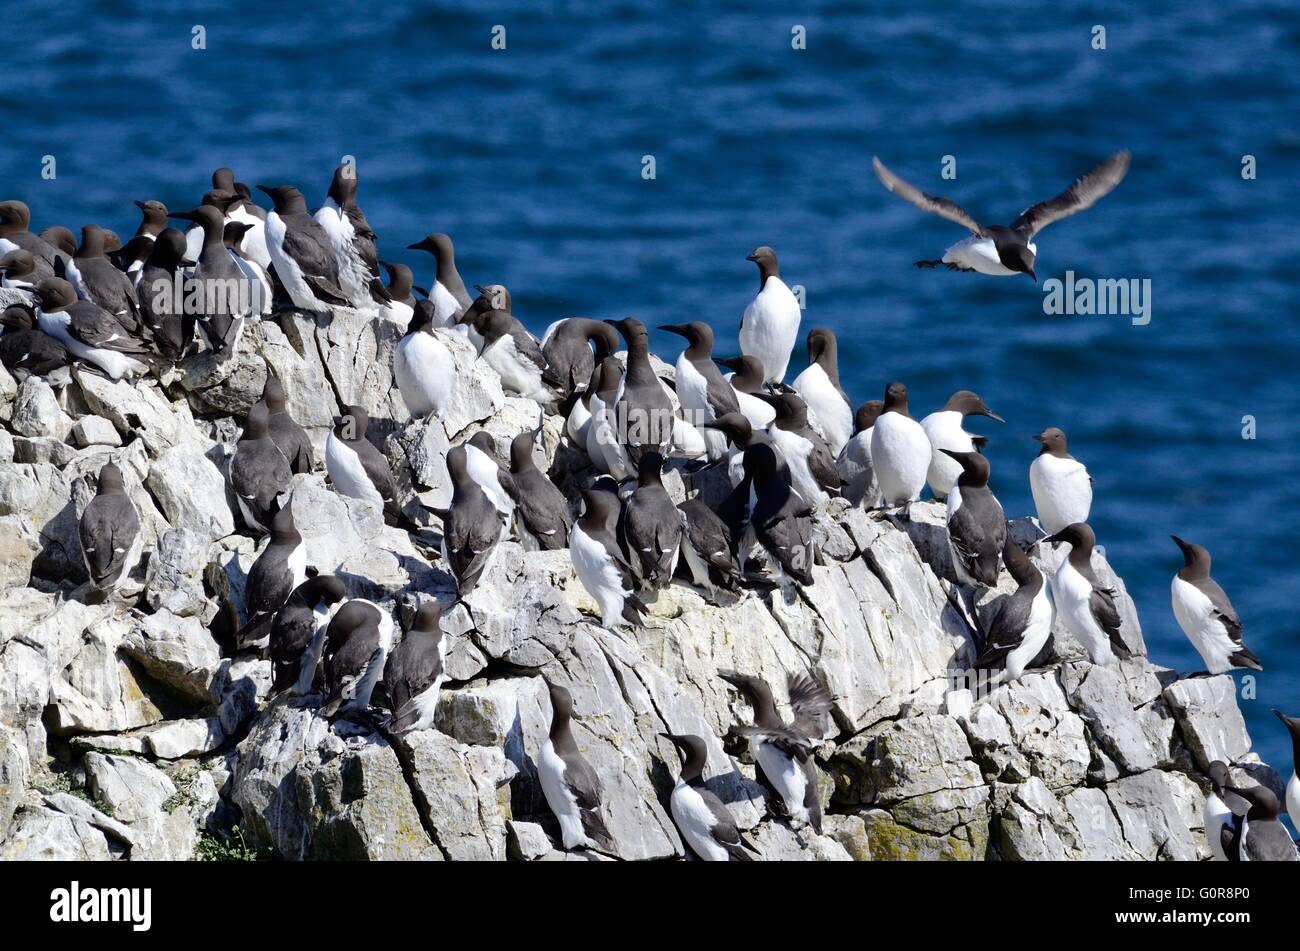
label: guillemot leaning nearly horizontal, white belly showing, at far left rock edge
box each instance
[36,272,150,379]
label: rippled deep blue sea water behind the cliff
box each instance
[0,0,1300,770]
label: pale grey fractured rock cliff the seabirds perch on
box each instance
[0,298,1277,860]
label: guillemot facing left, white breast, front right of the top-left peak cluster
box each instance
[257,184,351,312]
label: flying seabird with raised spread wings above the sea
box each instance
[871,152,1132,281]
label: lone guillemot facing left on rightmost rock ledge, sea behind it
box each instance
[1170,535,1264,674]
